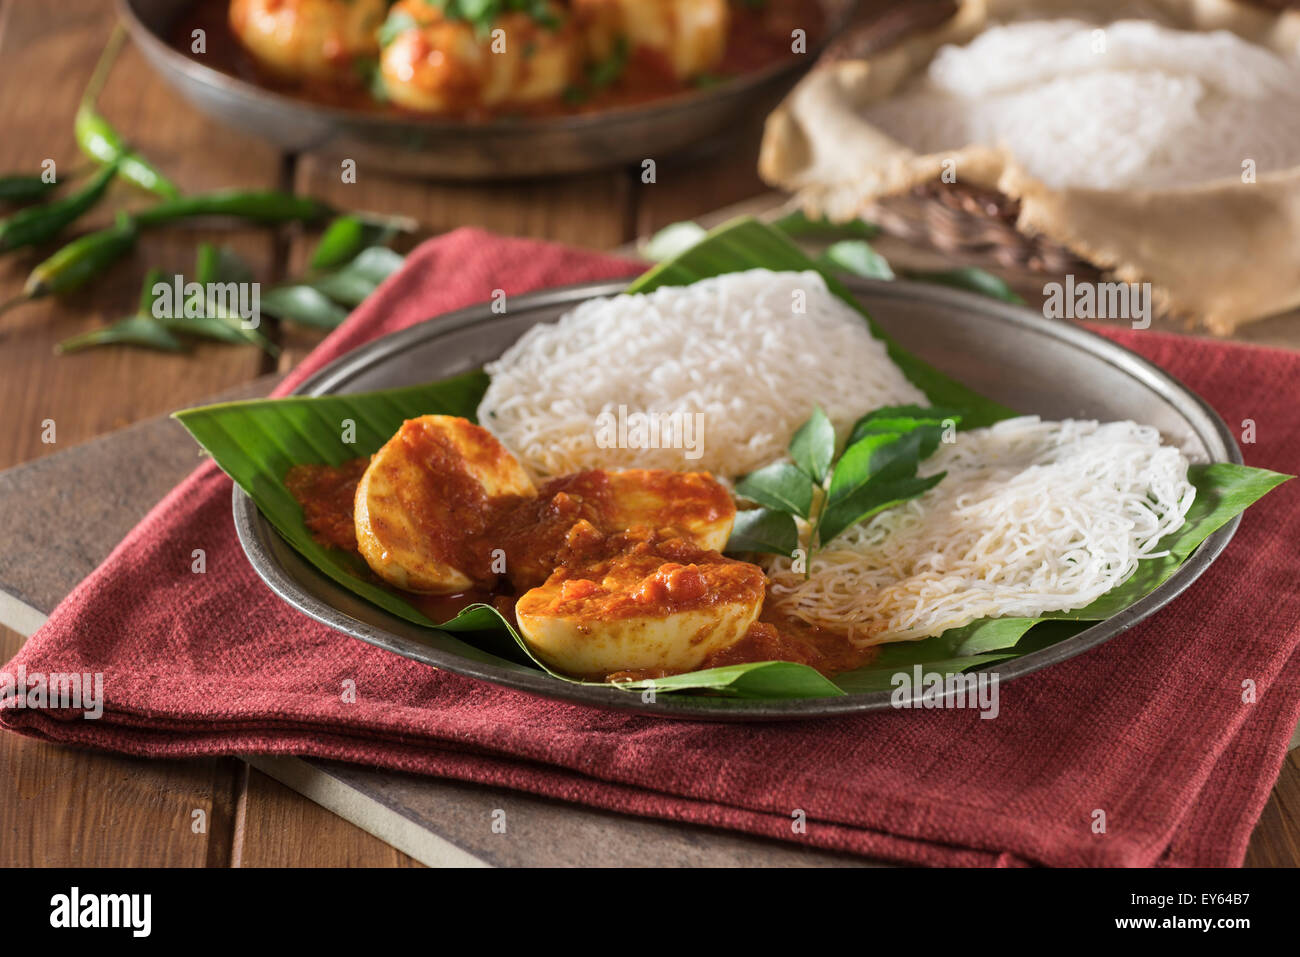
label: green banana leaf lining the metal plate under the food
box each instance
[176,220,1290,698]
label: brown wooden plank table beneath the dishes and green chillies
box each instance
[0,0,1300,866]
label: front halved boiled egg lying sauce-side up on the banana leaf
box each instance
[515,538,766,679]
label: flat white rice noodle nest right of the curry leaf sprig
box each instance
[768,416,1195,645]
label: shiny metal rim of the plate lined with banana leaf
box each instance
[233,280,1242,720]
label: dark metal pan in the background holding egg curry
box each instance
[117,0,857,179]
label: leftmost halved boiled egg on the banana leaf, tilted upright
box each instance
[354,415,537,594]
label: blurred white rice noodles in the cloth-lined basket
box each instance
[866,20,1300,190]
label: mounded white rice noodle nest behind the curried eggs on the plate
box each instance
[478,269,926,477]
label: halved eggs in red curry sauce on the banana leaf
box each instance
[285,415,863,681]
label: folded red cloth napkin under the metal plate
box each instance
[0,230,1300,865]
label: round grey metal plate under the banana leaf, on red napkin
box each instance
[234,280,1242,720]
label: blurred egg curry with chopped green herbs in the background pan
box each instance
[205,0,823,118]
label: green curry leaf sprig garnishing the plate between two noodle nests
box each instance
[727,406,961,570]
